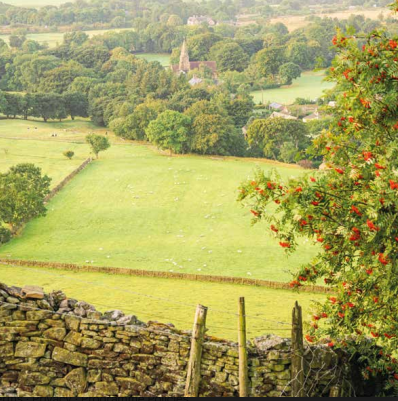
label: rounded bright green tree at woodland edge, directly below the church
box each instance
[146,110,191,155]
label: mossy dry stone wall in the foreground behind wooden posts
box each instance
[0,284,351,397]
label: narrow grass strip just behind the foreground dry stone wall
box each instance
[0,266,324,341]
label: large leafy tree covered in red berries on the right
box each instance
[240,27,398,383]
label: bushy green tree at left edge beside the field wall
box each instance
[0,163,51,232]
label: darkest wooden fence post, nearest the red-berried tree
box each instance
[292,302,305,398]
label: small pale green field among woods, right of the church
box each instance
[252,71,334,105]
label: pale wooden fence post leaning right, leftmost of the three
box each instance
[185,305,207,398]
